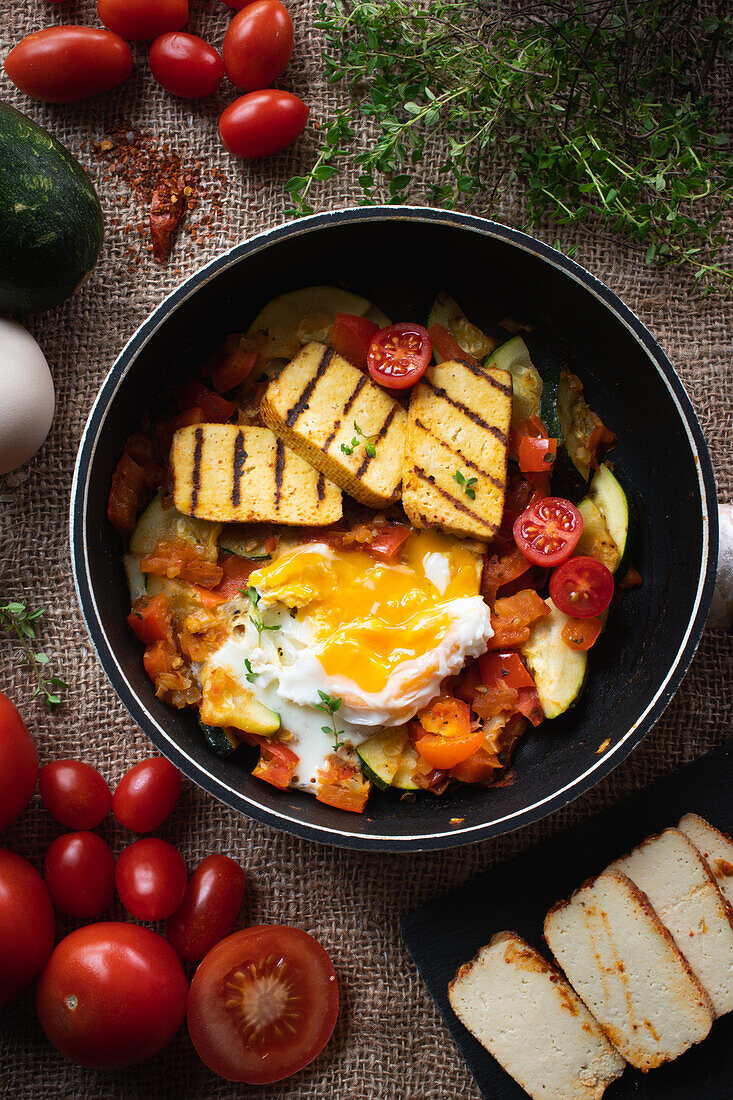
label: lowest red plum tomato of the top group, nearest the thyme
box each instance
[219,88,310,161]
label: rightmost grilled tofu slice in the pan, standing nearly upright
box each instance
[402,361,512,542]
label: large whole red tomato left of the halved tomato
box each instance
[35,921,188,1069]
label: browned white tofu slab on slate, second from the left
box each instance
[545,871,714,1070]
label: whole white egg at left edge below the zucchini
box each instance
[0,318,54,474]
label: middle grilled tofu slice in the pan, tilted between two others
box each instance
[260,342,406,508]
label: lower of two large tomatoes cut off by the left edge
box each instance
[0,848,56,1005]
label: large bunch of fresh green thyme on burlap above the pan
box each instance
[286,0,733,292]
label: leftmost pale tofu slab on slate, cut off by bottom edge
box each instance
[448,932,626,1100]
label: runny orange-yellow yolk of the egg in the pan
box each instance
[250,531,481,692]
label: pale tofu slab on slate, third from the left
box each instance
[606,828,733,1016]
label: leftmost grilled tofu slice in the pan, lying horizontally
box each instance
[171,424,341,527]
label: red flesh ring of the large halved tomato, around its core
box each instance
[187,925,339,1085]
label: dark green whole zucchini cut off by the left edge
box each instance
[0,103,102,314]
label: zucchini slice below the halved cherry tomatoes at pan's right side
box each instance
[519,600,588,718]
